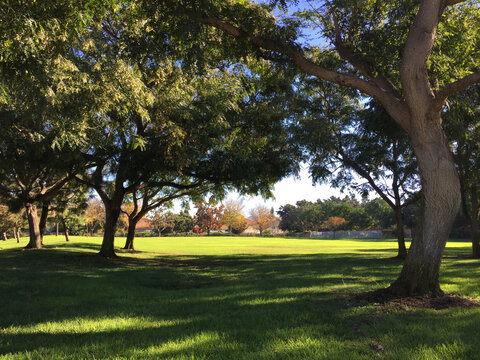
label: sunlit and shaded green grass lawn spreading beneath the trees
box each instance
[0,236,480,360]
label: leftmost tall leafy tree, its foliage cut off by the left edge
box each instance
[0,1,109,248]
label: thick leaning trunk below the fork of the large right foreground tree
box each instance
[390,125,460,296]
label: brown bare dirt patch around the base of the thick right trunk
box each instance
[355,289,480,310]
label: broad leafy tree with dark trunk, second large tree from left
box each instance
[74,8,298,257]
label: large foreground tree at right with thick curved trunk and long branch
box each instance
[182,0,480,295]
